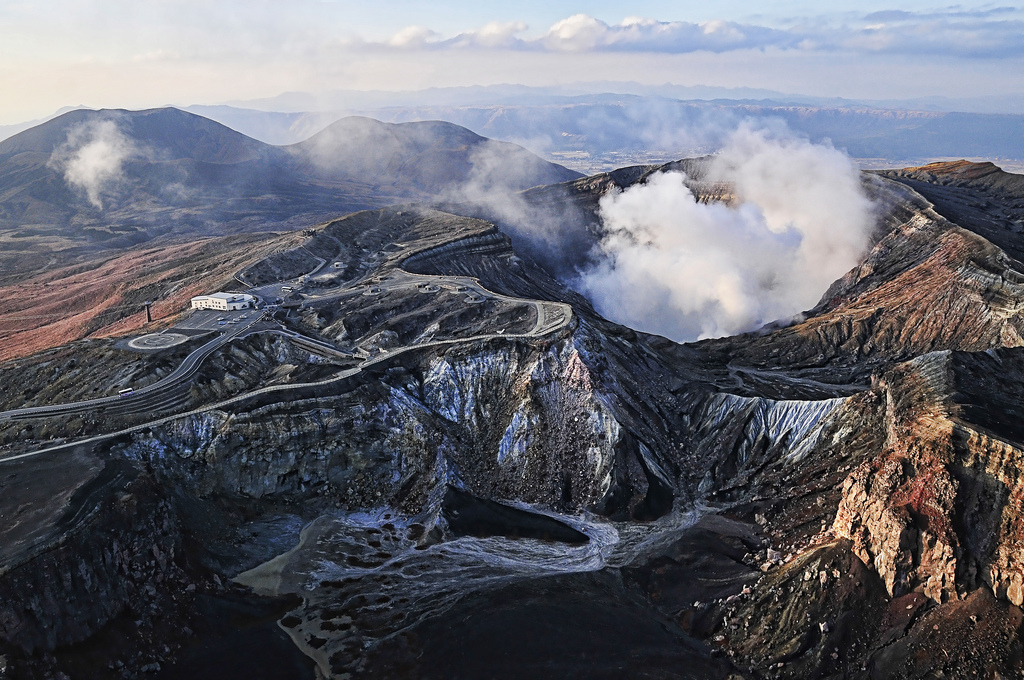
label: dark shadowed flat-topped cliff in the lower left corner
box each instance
[0,451,197,677]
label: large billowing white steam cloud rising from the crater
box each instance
[579,124,873,341]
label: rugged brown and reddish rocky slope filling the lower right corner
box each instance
[671,349,1024,678]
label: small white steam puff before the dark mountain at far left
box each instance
[49,120,135,209]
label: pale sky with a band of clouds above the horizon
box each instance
[0,0,1024,124]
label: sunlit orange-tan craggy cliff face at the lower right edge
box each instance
[833,349,1024,604]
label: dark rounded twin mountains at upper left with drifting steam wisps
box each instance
[0,109,579,278]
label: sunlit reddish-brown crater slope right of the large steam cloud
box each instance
[706,175,1024,391]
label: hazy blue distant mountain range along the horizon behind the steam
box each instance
[180,93,1024,174]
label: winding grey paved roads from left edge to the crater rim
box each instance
[0,242,572,463]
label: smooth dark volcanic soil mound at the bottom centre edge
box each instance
[366,572,733,680]
